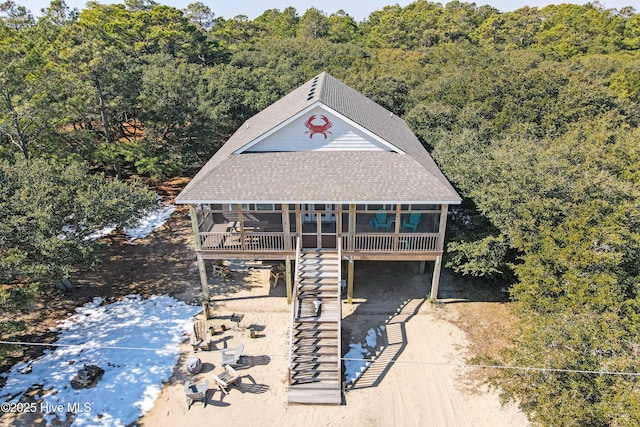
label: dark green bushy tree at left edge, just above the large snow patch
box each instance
[0,159,156,308]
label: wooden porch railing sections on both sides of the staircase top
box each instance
[200,232,440,253]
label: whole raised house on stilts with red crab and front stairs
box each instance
[176,73,461,403]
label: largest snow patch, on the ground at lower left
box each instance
[0,295,200,426]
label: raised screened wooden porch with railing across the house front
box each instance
[191,204,447,260]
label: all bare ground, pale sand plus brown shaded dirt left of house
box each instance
[0,198,528,427]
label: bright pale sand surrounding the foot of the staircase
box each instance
[140,262,528,427]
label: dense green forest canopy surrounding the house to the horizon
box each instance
[0,0,640,426]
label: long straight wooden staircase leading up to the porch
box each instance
[289,241,342,405]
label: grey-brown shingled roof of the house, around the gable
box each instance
[176,72,461,204]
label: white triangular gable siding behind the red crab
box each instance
[247,107,391,152]
